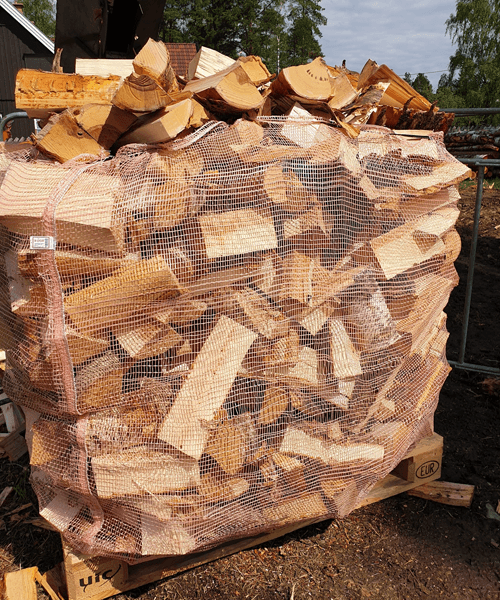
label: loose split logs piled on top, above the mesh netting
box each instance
[16,40,452,162]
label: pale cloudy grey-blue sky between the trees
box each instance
[320,0,456,90]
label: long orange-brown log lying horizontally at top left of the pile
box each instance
[15,69,120,119]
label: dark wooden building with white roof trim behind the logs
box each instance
[0,0,54,139]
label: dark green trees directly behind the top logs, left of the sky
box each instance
[160,0,326,72]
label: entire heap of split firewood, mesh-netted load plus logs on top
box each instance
[0,43,469,561]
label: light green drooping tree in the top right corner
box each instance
[442,0,500,119]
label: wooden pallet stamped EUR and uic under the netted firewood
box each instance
[41,433,443,600]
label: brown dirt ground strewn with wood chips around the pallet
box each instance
[0,187,500,600]
